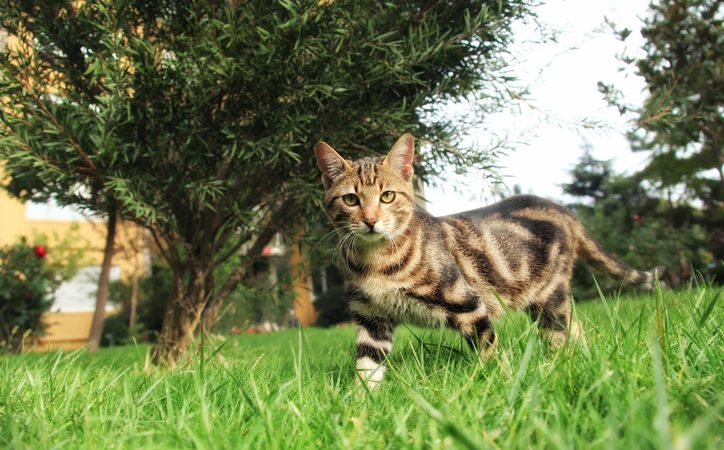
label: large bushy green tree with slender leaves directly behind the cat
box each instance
[0,0,528,363]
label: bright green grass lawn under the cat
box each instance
[0,286,724,449]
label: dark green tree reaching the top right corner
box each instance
[600,0,724,268]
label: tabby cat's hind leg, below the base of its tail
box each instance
[527,283,583,348]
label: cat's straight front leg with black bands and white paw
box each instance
[354,314,394,389]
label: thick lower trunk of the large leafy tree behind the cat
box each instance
[151,264,211,367]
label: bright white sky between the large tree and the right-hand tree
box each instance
[425,0,648,215]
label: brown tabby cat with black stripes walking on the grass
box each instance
[315,134,657,387]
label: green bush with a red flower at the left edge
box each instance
[0,241,60,352]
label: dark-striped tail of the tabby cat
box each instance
[578,232,665,289]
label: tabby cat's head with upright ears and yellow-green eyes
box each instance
[315,133,415,243]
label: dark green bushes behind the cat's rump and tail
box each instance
[563,154,721,298]
